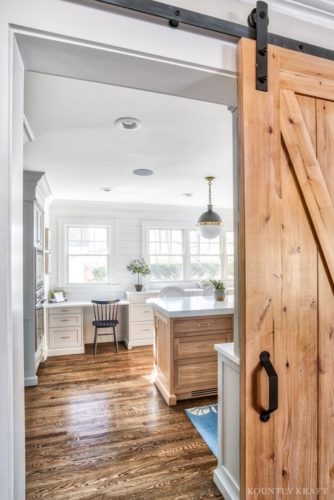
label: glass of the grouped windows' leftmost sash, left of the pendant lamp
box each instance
[148,229,184,281]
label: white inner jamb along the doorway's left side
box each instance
[8,38,25,499]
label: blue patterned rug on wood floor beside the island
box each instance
[185,404,218,457]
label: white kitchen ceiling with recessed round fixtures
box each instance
[24,72,232,208]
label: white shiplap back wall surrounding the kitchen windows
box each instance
[50,199,233,300]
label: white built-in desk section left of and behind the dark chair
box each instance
[44,300,129,356]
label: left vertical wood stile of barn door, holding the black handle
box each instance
[238,40,282,500]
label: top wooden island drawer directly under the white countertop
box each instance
[173,316,233,337]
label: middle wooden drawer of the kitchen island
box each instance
[174,332,233,359]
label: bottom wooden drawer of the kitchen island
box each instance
[175,355,218,393]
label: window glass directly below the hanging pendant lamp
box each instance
[189,231,222,280]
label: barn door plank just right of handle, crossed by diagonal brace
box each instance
[276,96,318,498]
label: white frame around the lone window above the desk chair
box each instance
[58,217,116,289]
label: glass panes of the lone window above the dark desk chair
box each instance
[66,226,110,284]
